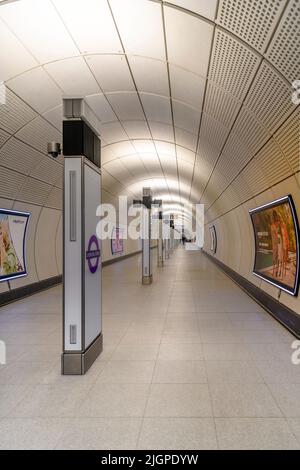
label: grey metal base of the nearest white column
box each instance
[61,333,103,375]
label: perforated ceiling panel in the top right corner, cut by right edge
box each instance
[267,0,300,81]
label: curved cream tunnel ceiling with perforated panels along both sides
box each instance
[0,0,300,218]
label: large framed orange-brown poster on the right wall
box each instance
[249,196,299,295]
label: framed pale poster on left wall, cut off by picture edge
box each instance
[0,209,30,282]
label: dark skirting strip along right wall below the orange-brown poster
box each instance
[203,250,300,338]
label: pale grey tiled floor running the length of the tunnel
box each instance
[0,248,300,449]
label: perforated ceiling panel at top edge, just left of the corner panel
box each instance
[217,0,285,52]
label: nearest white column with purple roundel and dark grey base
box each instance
[62,99,103,375]
